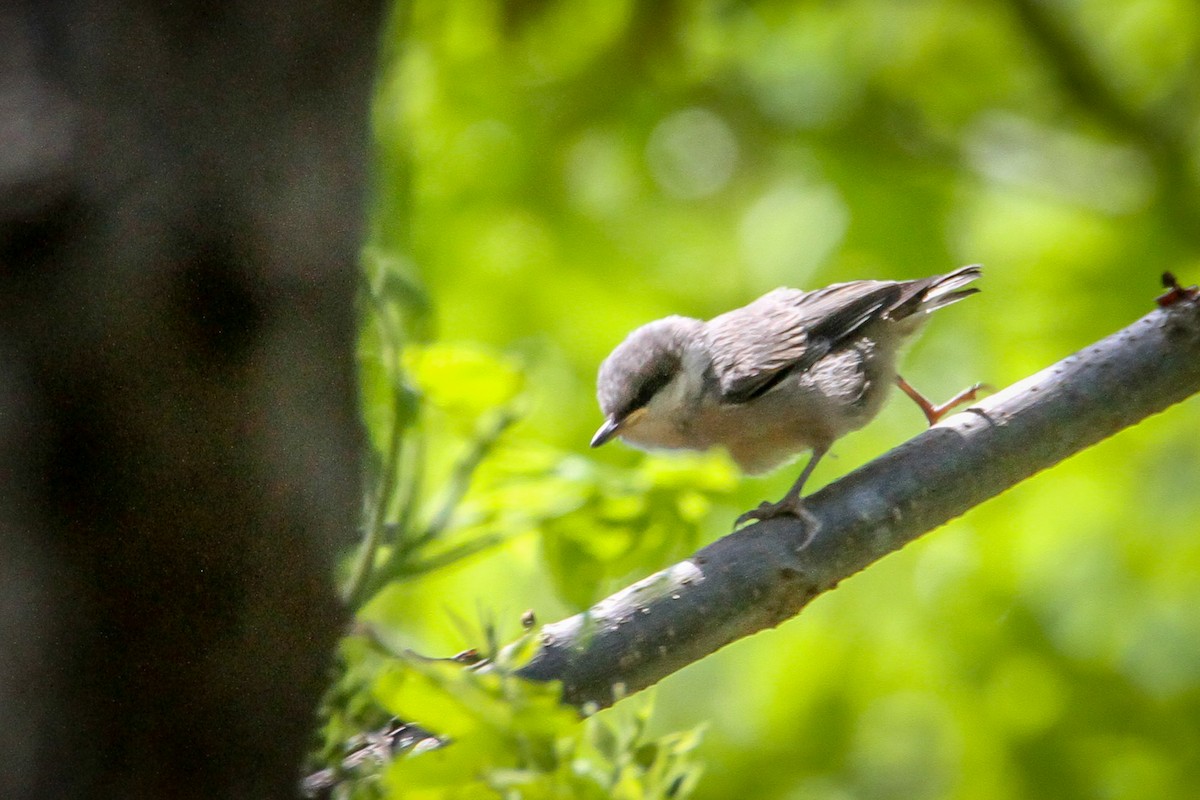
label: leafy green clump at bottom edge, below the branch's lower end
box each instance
[320,614,700,800]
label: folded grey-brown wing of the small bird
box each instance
[704,281,902,403]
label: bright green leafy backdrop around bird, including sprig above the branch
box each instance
[330,0,1200,800]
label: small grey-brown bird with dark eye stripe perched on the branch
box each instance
[592,264,984,527]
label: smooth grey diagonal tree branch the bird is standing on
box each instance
[517,293,1200,706]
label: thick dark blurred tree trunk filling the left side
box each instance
[0,0,380,800]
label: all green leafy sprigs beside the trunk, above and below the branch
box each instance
[314,219,715,800]
